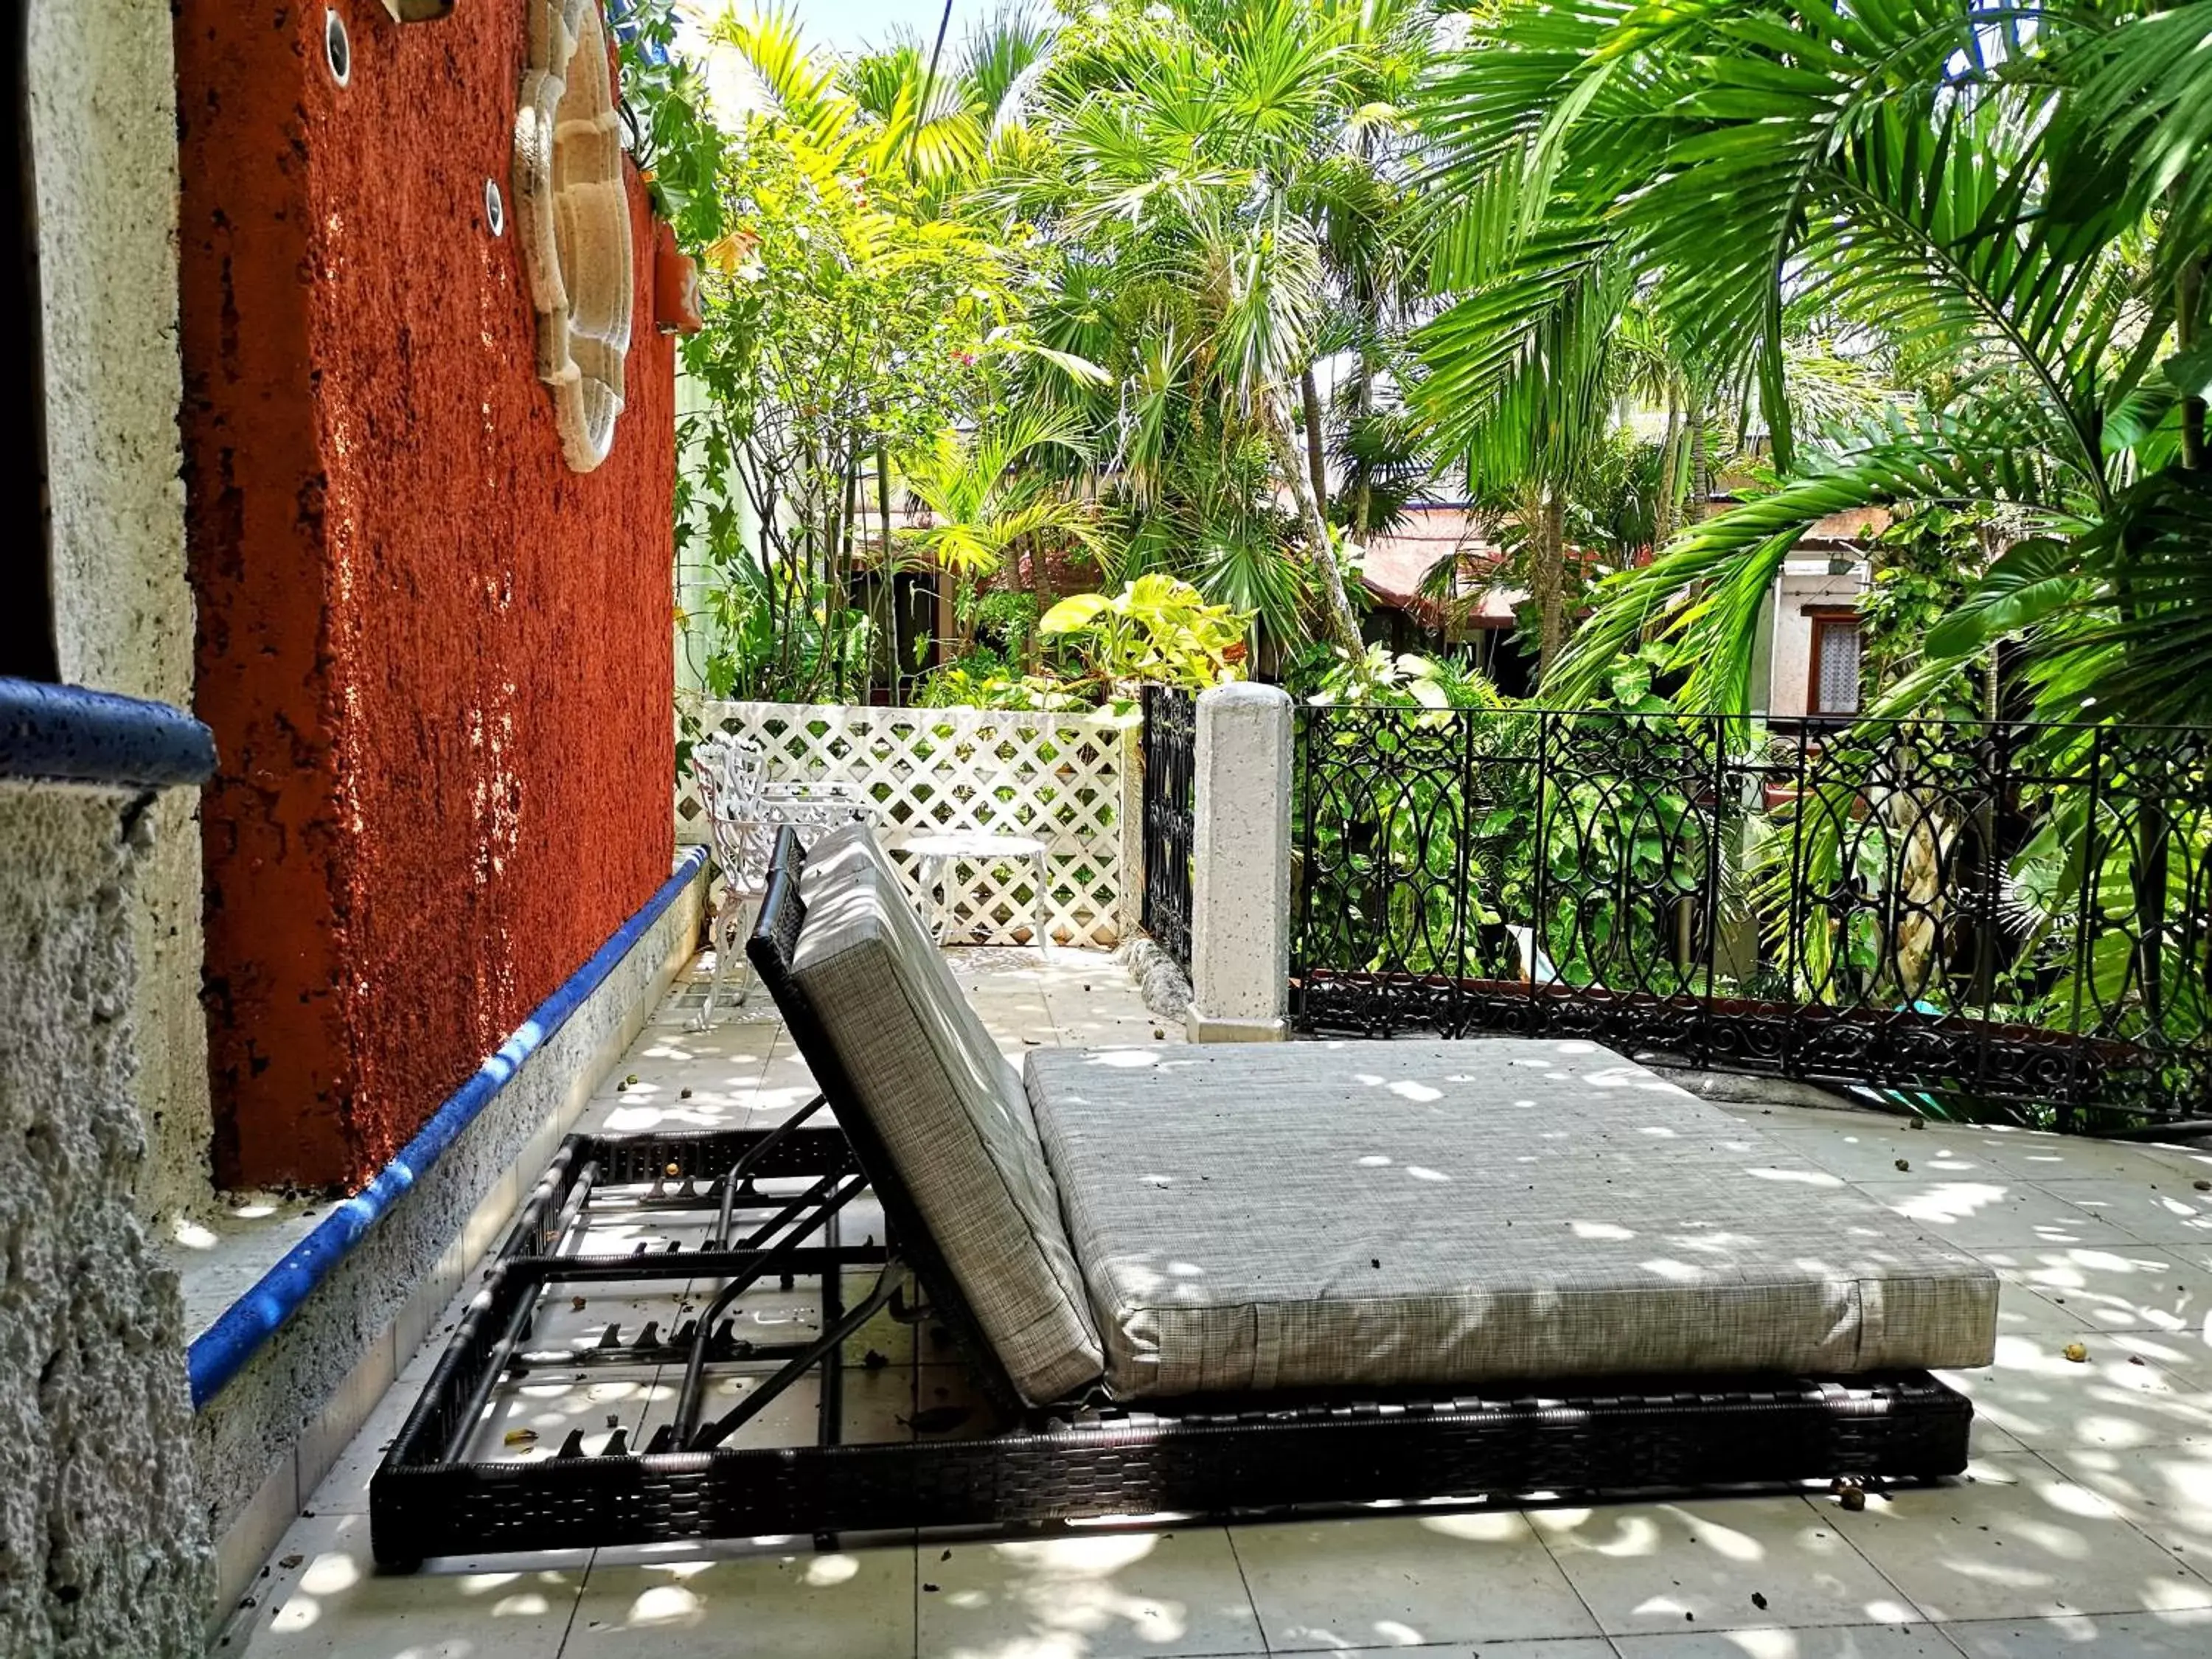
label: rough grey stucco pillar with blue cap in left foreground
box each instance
[0,686,212,1659]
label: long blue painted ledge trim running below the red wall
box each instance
[186,847,706,1407]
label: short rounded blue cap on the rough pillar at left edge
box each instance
[0,679,215,790]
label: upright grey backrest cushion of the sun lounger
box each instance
[792,825,1104,1402]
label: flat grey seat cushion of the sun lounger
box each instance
[1026,1040,1997,1398]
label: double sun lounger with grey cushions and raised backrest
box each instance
[372,832,1997,1564]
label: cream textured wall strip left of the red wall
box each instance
[30,0,215,1225]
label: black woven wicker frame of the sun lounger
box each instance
[369,830,1973,1568]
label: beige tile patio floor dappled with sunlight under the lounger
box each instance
[217,951,2212,1659]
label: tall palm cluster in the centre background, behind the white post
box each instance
[989,0,1427,655]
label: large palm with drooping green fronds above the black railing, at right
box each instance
[1422,0,2212,721]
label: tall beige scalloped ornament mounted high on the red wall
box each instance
[513,0,637,473]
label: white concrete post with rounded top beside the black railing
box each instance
[1186,684,1290,1042]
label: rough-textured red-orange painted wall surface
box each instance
[177,0,675,1186]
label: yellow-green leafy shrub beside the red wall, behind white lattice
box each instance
[679,117,1015,701]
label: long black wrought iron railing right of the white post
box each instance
[1292,708,2212,1128]
